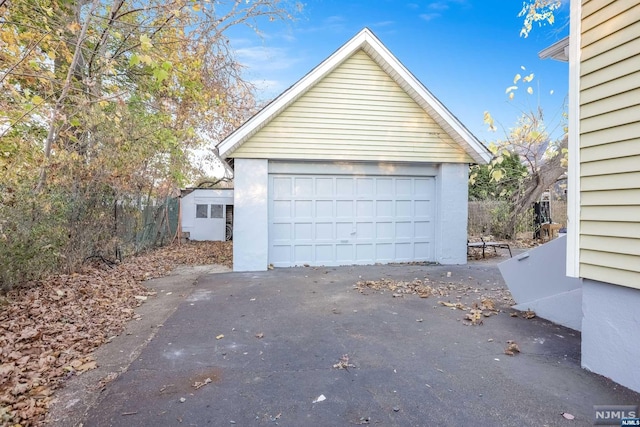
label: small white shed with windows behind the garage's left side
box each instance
[180,188,233,241]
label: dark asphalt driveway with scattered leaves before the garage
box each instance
[58,261,640,426]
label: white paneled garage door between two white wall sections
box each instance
[269,174,435,267]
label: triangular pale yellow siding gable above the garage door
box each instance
[233,50,474,163]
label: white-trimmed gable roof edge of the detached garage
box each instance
[218,28,492,164]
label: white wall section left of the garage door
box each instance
[233,159,269,271]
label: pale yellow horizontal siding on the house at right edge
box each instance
[580,0,640,289]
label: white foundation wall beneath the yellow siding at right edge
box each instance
[582,279,640,392]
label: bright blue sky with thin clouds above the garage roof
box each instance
[230,0,569,142]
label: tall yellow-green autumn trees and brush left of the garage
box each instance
[0,0,300,287]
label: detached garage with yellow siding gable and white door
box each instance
[218,28,491,271]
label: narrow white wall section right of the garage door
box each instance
[436,163,469,264]
